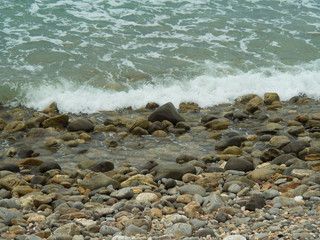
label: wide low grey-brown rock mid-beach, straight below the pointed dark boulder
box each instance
[150,163,196,181]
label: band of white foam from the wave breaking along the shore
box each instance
[23,62,320,113]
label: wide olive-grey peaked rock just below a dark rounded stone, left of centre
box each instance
[79,173,119,190]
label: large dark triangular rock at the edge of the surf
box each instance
[148,102,185,125]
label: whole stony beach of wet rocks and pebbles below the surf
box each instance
[0,92,320,240]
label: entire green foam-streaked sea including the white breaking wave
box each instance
[0,0,320,113]
